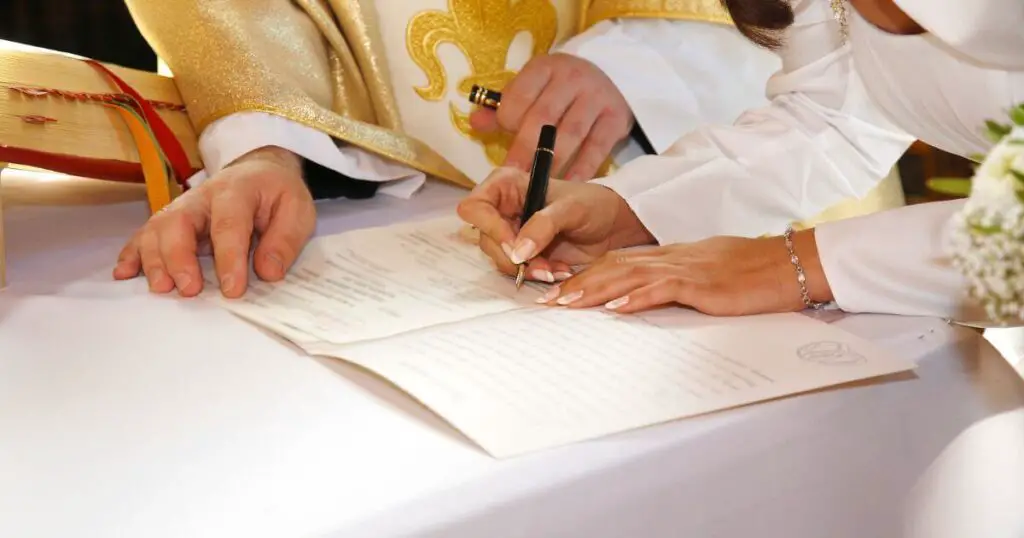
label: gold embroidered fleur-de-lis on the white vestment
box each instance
[406,0,558,165]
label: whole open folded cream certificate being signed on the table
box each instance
[207,218,913,457]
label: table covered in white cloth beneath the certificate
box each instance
[0,175,1024,538]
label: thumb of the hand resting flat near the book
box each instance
[253,198,316,282]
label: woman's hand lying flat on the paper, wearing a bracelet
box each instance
[541,231,833,316]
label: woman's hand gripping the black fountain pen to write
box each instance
[459,168,653,283]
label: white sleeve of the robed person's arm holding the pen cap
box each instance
[559,18,782,153]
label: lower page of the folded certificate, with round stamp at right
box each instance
[317,308,912,457]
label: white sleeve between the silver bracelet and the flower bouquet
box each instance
[814,200,986,322]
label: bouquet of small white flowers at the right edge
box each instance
[952,105,1024,323]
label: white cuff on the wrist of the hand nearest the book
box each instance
[189,112,426,198]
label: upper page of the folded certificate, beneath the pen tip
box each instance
[204,218,541,343]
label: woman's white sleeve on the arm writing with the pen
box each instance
[596,0,913,244]
